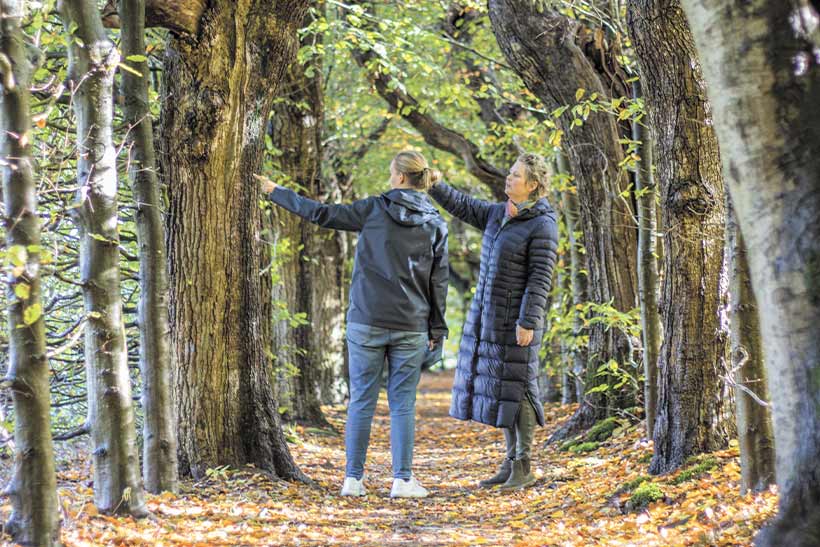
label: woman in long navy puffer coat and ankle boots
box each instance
[430,154,558,489]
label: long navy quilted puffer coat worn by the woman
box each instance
[430,183,558,428]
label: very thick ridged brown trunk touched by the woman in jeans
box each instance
[161,0,307,479]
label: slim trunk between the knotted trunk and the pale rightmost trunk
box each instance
[726,195,775,493]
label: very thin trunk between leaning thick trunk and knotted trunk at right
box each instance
[632,82,661,439]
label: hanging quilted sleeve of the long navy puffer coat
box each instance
[517,220,558,330]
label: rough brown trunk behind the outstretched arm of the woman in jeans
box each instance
[271,27,346,426]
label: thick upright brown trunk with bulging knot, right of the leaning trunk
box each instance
[628,0,732,473]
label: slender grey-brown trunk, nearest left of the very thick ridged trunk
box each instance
[119,0,177,494]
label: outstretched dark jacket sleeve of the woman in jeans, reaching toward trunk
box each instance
[268,186,373,232]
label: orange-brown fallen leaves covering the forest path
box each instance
[3,373,777,547]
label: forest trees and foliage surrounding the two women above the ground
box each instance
[0,0,820,545]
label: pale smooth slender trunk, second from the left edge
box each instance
[61,0,147,516]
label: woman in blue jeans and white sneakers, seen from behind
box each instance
[258,151,449,497]
